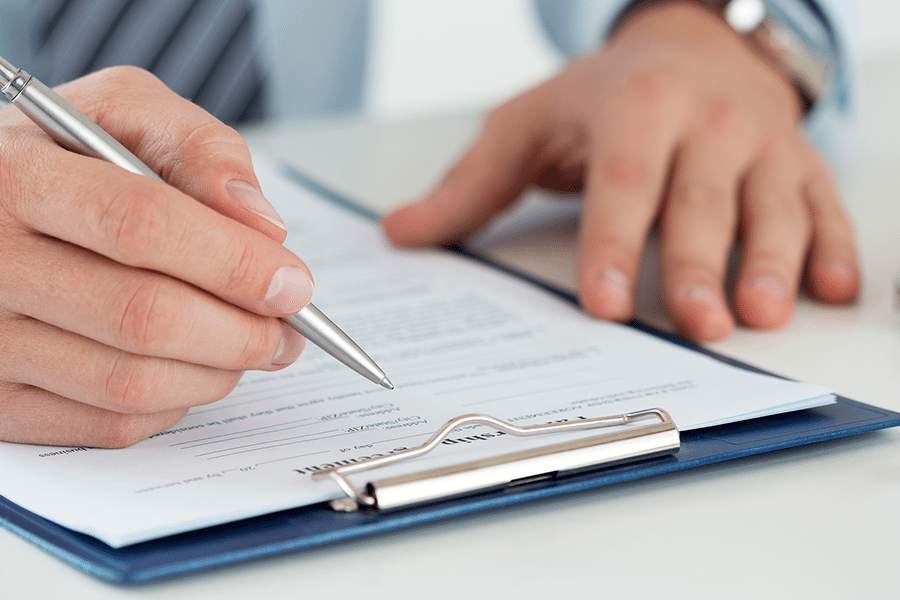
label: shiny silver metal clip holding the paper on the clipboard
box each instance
[313,408,681,512]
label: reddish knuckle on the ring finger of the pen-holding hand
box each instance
[104,352,163,414]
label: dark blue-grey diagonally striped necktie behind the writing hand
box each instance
[34,0,264,123]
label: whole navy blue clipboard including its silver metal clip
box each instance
[0,167,900,584]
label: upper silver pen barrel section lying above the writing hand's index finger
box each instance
[12,77,161,181]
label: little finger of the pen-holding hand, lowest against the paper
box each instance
[0,384,186,448]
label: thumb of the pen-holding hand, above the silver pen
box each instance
[58,67,287,243]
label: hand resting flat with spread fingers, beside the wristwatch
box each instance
[384,2,859,340]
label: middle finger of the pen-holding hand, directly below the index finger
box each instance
[0,236,303,371]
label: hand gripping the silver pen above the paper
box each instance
[0,68,313,447]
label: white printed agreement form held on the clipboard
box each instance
[0,157,834,547]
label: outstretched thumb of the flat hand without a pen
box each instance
[383,84,552,245]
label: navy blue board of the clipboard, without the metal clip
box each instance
[0,164,900,584]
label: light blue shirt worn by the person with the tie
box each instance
[0,0,852,158]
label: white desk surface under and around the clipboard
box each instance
[7,61,900,600]
